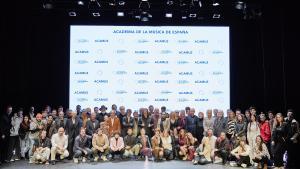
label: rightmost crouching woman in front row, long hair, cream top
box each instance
[252,136,270,169]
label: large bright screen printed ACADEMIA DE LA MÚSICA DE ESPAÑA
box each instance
[69,25,230,111]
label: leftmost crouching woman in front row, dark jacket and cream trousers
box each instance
[29,130,51,164]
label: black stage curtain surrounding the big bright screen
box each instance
[0,1,300,117]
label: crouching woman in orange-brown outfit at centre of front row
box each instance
[151,128,164,161]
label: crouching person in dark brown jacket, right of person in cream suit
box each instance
[214,132,230,164]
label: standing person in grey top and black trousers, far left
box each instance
[7,112,22,162]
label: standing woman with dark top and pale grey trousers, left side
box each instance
[19,115,31,158]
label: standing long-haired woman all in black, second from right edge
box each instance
[271,113,288,169]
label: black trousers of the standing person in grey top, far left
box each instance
[7,136,21,160]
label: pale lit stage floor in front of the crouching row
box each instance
[0,160,232,169]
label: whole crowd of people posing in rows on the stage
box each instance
[0,105,299,169]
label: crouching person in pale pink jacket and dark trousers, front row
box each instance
[110,132,124,160]
